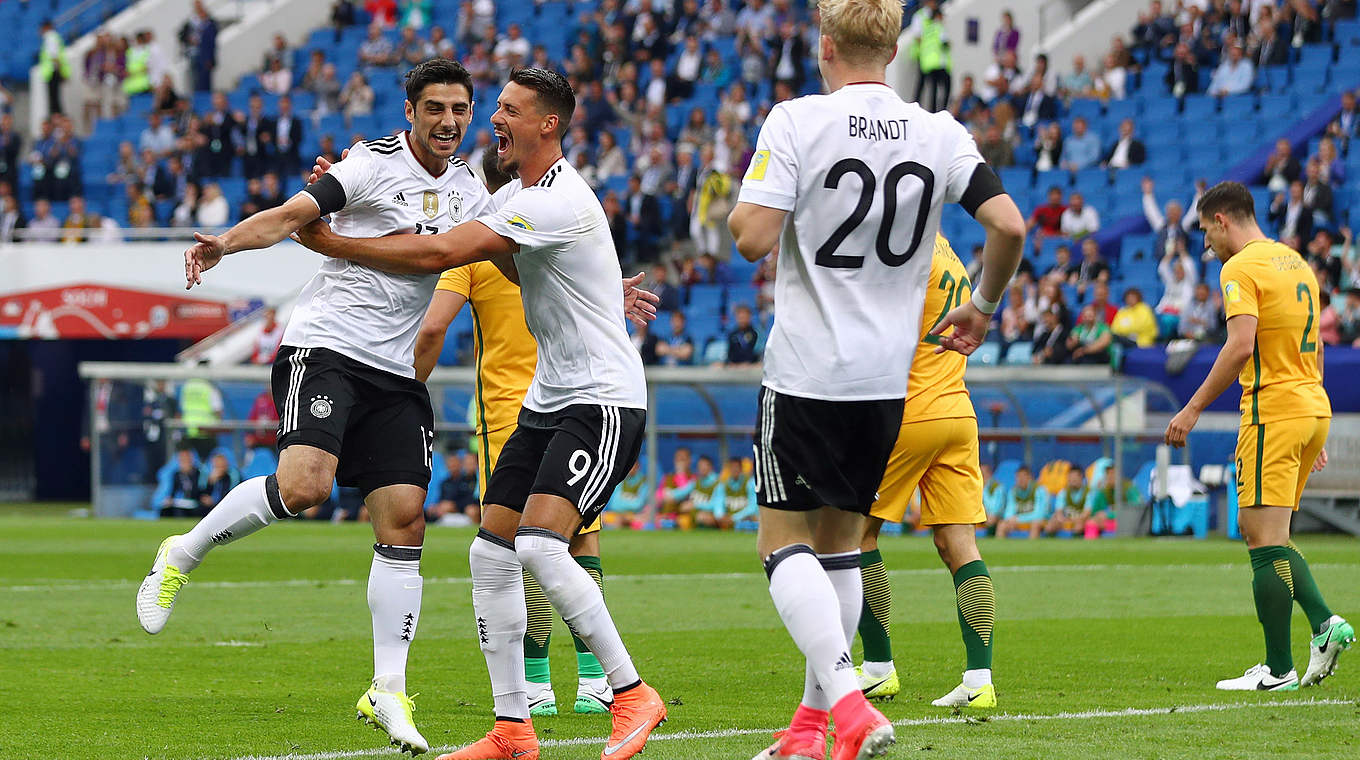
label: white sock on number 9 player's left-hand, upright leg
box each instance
[468,530,529,721]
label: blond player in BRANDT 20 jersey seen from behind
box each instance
[729,0,1024,760]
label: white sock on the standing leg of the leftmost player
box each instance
[369,544,424,692]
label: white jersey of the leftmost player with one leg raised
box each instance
[283,132,490,378]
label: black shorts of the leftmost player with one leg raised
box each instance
[271,345,434,496]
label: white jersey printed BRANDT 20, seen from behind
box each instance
[738,84,983,401]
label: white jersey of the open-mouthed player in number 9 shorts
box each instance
[477,159,647,412]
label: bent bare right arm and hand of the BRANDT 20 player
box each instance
[930,193,1025,356]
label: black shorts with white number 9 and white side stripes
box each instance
[481,404,647,525]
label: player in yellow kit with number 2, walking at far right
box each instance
[1166,182,1356,691]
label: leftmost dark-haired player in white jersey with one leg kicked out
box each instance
[137,60,490,753]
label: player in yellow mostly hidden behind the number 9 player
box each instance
[415,151,656,715]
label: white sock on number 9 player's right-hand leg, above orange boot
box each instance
[514,528,641,689]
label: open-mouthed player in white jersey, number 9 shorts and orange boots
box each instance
[291,68,663,760]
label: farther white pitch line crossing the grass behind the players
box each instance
[0,562,1356,594]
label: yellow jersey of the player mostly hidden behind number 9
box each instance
[437,261,539,435]
